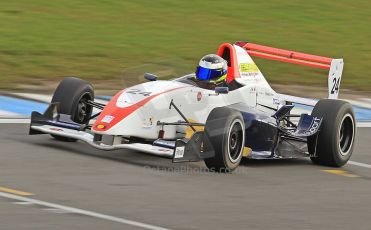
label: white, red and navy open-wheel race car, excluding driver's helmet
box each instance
[29,42,356,172]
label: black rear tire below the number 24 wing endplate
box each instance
[308,99,356,167]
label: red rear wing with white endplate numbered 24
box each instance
[235,42,344,99]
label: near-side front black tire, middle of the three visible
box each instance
[204,107,245,173]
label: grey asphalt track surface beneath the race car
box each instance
[0,124,371,230]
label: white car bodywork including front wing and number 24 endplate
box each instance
[31,42,344,156]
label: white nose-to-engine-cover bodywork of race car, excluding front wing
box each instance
[92,45,285,139]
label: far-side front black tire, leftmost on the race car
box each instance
[52,77,94,142]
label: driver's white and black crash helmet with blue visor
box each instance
[196,54,228,83]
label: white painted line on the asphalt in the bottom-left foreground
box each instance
[0,192,168,230]
